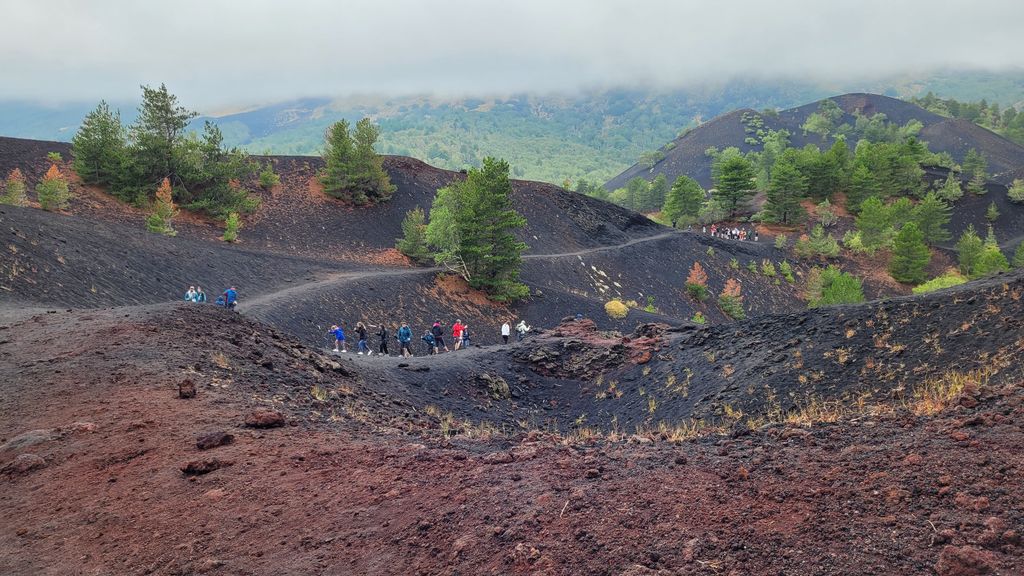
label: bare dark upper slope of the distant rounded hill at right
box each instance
[604,93,1024,190]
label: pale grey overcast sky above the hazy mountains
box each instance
[0,0,1024,109]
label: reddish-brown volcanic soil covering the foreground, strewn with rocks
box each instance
[0,304,1024,576]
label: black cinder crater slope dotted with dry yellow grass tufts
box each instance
[366,273,1024,430]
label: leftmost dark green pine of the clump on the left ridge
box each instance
[71,100,127,186]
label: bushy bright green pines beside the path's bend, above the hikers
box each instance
[396,157,529,301]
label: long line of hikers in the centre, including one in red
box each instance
[328,320,530,357]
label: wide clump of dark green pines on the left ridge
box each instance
[72,84,258,217]
